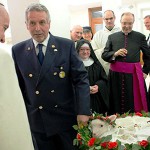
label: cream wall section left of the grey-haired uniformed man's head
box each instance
[7,0,38,44]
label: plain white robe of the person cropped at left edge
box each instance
[0,49,34,150]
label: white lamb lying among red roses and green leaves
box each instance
[90,115,150,144]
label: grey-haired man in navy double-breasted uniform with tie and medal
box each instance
[12,3,90,150]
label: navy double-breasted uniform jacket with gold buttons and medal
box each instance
[12,34,90,135]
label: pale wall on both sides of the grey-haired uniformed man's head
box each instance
[8,0,70,44]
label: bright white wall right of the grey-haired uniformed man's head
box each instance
[40,0,70,38]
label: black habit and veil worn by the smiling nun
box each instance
[76,39,109,114]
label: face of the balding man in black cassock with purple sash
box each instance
[121,15,134,34]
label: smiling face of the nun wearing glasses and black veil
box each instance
[79,46,91,60]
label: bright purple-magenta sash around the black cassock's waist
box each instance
[110,62,148,112]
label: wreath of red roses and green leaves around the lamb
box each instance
[73,112,150,150]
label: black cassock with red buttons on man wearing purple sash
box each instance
[102,31,150,114]
